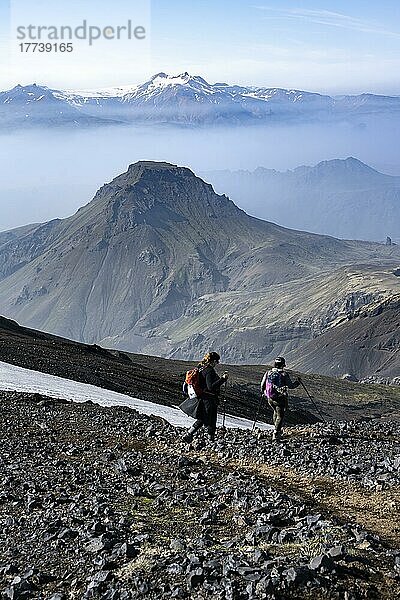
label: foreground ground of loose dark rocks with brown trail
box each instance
[0,392,400,600]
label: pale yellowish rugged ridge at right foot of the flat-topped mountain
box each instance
[146,263,398,375]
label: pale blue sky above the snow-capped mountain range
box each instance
[0,0,400,95]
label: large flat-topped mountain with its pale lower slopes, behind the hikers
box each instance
[0,162,400,363]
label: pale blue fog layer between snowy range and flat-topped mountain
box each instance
[0,117,400,231]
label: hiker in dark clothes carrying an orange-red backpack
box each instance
[179,352,228,443]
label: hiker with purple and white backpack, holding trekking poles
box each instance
[261,356,301,440]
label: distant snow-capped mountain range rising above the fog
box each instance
[0,72,400,128]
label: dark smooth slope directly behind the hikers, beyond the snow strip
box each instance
[0,317,400,423]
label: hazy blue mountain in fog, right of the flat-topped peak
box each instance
[204,157,400,241]
